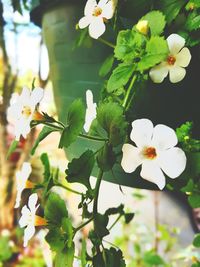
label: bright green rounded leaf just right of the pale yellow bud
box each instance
[141,10,166,35]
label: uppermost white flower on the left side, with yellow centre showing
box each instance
[8,87,44,141]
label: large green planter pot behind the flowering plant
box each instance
[31,1,200,189]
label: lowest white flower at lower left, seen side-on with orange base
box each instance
[19,193,47,247]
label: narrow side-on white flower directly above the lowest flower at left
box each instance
[15,162,33,209]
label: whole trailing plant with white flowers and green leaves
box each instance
[4,0,200,267]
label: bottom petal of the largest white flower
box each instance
[140,160,165,190]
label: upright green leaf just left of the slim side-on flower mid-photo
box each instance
[59,99,85,148]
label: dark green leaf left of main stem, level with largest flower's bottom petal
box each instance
[66,150,95,189]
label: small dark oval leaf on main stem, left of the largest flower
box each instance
[97,143,116,172]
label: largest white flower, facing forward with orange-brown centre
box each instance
[121,119,186,189]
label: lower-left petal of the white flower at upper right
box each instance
[149,63,169,83]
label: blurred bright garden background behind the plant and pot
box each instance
[0,0,200,267]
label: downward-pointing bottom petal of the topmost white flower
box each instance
[89,17,106,39]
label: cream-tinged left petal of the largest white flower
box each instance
[121,144,143,173]
